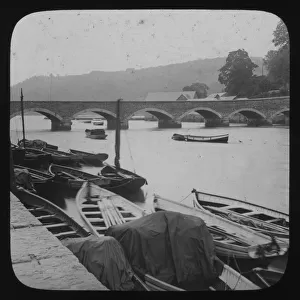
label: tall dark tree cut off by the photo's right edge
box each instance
[264,20,290,90]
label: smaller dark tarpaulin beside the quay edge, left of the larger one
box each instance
[62,236,134,291]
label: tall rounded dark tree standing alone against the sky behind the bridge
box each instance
[218,49,258,95]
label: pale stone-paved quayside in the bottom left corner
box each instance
[10,193,108,290]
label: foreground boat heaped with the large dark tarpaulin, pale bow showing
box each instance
[106,211,259,291]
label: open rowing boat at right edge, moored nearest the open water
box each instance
[192,189,289,238]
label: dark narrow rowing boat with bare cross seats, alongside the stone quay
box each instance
[16,189,90,240]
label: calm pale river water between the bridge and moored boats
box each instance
[10,116,289,226]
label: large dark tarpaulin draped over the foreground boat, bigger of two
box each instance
[106,211,218,287]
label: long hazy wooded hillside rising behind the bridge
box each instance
[11,57,262,101]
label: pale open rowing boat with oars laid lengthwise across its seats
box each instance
[76,182,148,236]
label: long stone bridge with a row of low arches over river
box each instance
[10,96,290,131]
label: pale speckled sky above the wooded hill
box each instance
[11,10,280,85]
